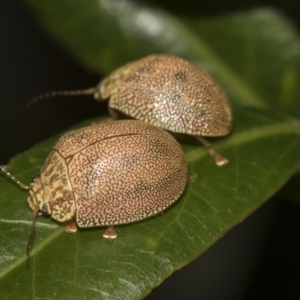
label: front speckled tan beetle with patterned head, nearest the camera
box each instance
[0,120,187,254]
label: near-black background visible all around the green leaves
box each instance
[0,0,300,300]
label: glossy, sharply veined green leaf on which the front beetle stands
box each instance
[0,109,300,299]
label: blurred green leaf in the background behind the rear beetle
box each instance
[24,0,300,117]
